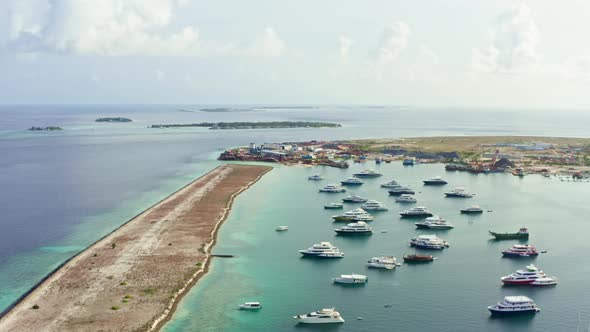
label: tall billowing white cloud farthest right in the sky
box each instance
[473,3,540,73]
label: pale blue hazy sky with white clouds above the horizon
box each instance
[0,0,590,110]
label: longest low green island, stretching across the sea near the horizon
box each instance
[150,121,342,129]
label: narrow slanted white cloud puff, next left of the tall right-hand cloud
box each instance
[375,21,411,64]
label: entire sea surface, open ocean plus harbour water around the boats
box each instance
[0,105,590,331]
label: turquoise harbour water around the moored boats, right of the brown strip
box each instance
[164,163,590,332]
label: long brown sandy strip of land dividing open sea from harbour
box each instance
[0,164,272,331]
